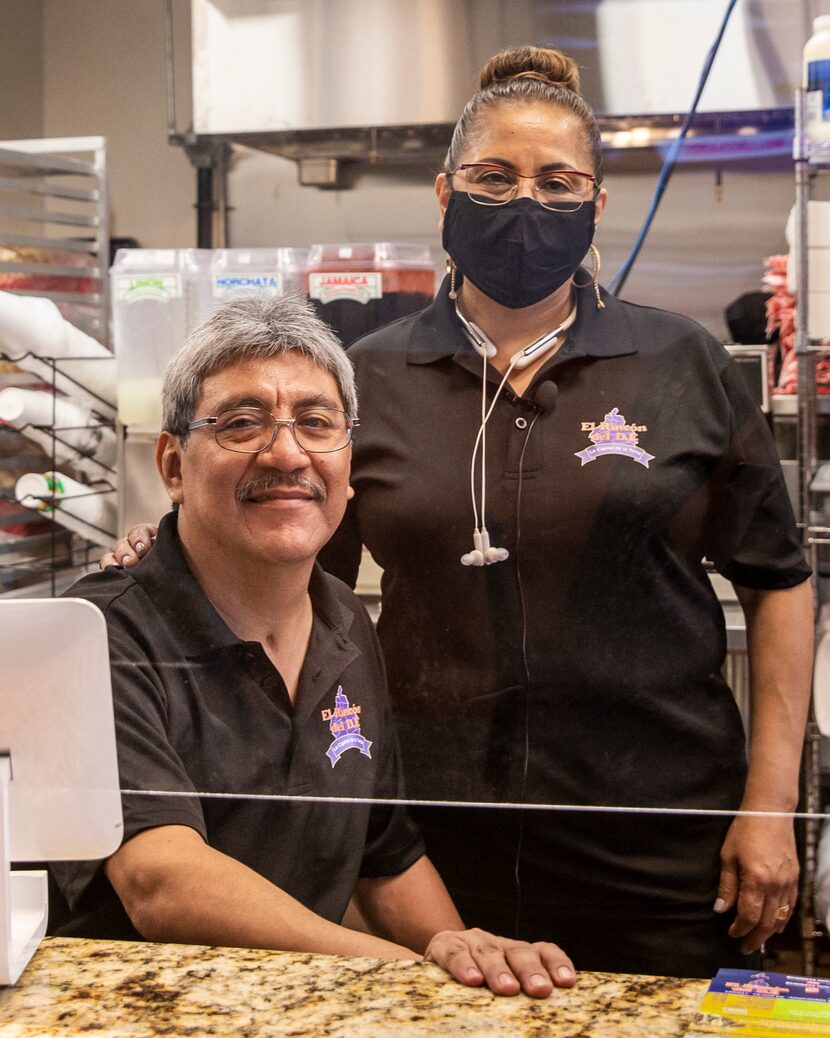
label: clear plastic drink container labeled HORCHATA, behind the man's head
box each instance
[211,248,308,305]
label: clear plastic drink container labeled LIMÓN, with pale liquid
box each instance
[110,249,212,428]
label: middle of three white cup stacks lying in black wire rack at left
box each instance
[0,386,117,468]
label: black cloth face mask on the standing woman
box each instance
[442,191,597,309]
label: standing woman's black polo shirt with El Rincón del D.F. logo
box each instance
[323,283,809,822]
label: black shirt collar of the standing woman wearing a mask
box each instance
[407,270,638,370]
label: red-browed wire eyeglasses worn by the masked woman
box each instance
[450,162,598,213]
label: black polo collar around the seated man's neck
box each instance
[130,512,354,657]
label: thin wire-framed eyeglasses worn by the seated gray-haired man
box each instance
[188,407,360,454]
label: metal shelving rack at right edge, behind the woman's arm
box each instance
[793,90,830,976]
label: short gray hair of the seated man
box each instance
[162,296,357,442]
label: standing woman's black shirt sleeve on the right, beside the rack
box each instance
[707,360,810,590]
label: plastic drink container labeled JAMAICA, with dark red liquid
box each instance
[306,242,435,347]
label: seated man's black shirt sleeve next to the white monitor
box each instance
[51,610,206,911]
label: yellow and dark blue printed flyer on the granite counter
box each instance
[687,969,830,1038]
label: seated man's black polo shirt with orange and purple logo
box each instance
[53,514,423,937]
